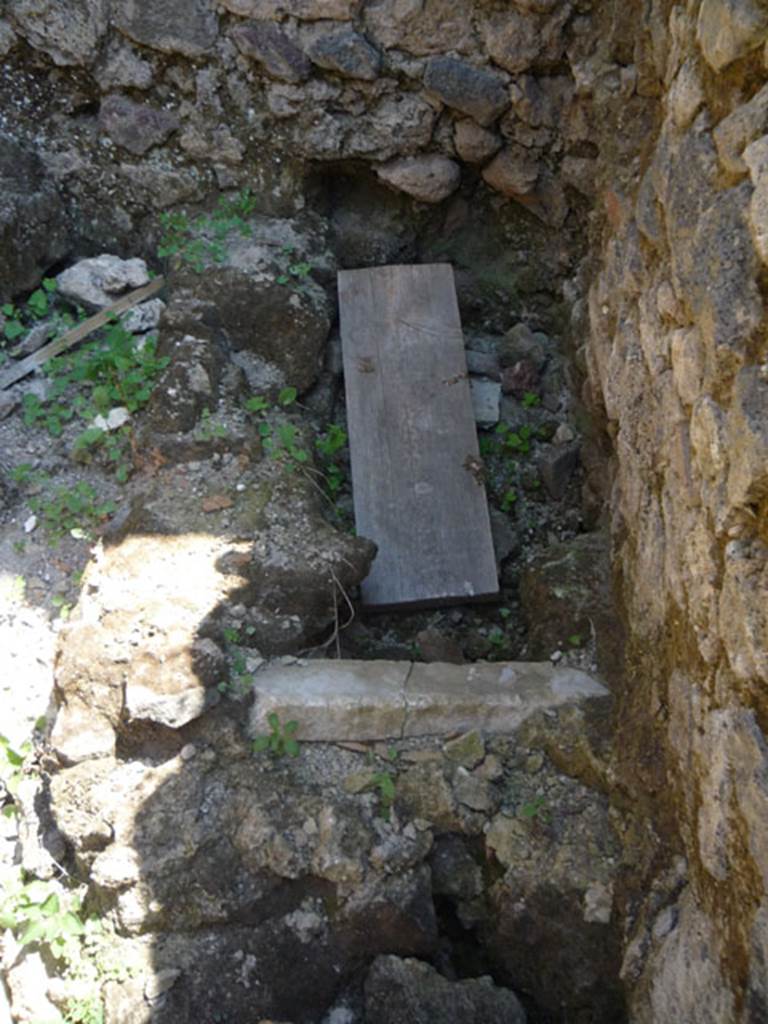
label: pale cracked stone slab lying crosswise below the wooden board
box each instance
[249,659,608,742]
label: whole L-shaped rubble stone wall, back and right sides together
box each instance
[0,0,768,1024]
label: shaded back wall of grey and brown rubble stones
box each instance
[0,0,602,262]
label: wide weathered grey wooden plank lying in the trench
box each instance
[339,263,499,607]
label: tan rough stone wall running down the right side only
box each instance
[588,0,768,1022]
